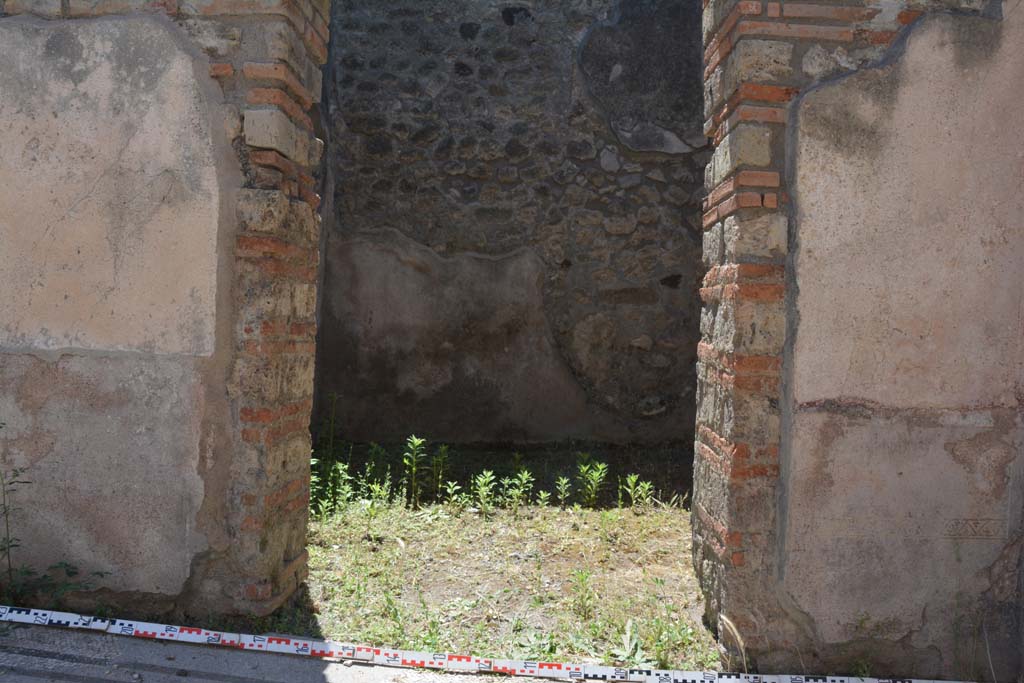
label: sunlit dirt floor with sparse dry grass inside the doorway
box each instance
[299,502,720,670]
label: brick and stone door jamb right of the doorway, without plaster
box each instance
[693,0,942,669]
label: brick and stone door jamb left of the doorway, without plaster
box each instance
[188,0,329,613]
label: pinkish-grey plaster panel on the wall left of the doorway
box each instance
[0,16,228,595]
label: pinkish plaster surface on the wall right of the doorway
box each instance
[780,12,1024,677]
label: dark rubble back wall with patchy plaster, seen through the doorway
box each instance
[317,0,709,442]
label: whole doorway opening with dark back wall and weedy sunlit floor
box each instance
[299,0,718,669]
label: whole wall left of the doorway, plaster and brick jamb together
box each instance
[0,0,328,614]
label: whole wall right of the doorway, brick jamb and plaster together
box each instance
[693,0,1024,679]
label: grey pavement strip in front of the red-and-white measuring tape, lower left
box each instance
[0,626,537,683]
